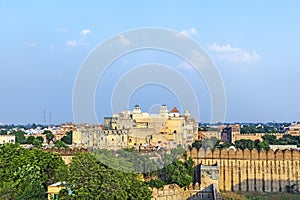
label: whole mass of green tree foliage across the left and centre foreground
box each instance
[0,144,193,200]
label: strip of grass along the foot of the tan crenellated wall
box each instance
[222,192,300,200]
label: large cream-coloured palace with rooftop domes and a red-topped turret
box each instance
[73,105,198,149]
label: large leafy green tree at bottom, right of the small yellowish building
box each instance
[68,153,151,200]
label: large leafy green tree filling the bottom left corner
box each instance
[0,144,68,200]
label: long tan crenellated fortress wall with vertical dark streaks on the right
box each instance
[188,148,300,192]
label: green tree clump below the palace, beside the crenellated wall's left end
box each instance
[93,146,194,188]
